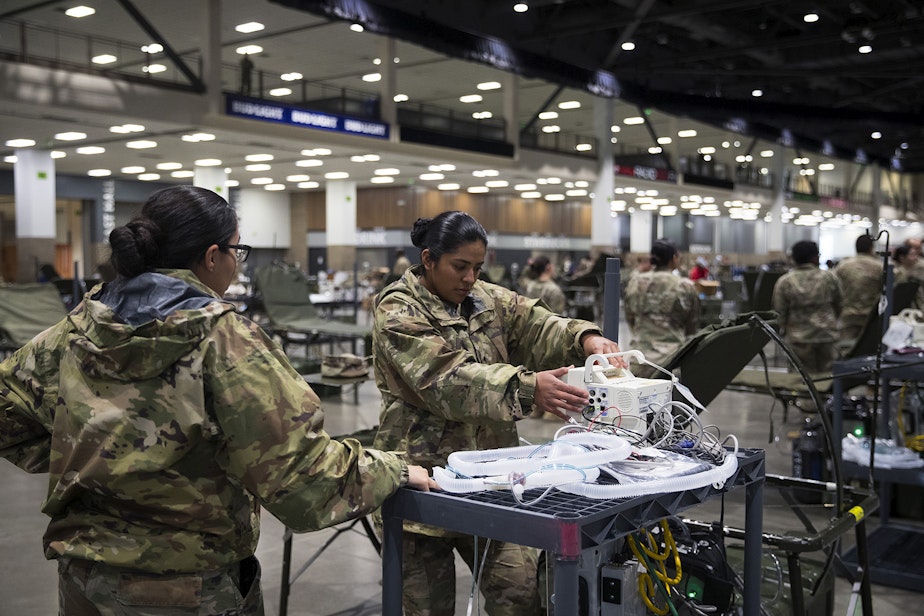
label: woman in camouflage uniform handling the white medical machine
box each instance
[372,212,619,616]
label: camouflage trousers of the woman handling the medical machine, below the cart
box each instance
[402,532,539,616]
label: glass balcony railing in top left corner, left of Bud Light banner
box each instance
[0,19,202,87]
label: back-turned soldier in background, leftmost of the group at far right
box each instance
[773,240,843,373]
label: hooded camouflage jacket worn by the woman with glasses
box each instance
[0,270,405,573]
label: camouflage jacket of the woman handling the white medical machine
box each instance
[372,265,600,534]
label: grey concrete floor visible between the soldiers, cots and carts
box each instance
[0,344,924,616]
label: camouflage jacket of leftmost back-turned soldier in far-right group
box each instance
[773,263,842,344]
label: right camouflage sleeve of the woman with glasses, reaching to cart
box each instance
[205,318,406,531]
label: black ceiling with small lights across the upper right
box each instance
[272,0,924,172]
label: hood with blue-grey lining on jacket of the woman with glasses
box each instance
[68,270,234,381]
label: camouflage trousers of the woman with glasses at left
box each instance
[58,556,263,616]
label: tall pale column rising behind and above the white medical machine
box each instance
[590,98,620,256]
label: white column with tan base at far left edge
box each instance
[13,149,56,282]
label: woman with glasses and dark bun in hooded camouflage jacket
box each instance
[0,186,435,616]
